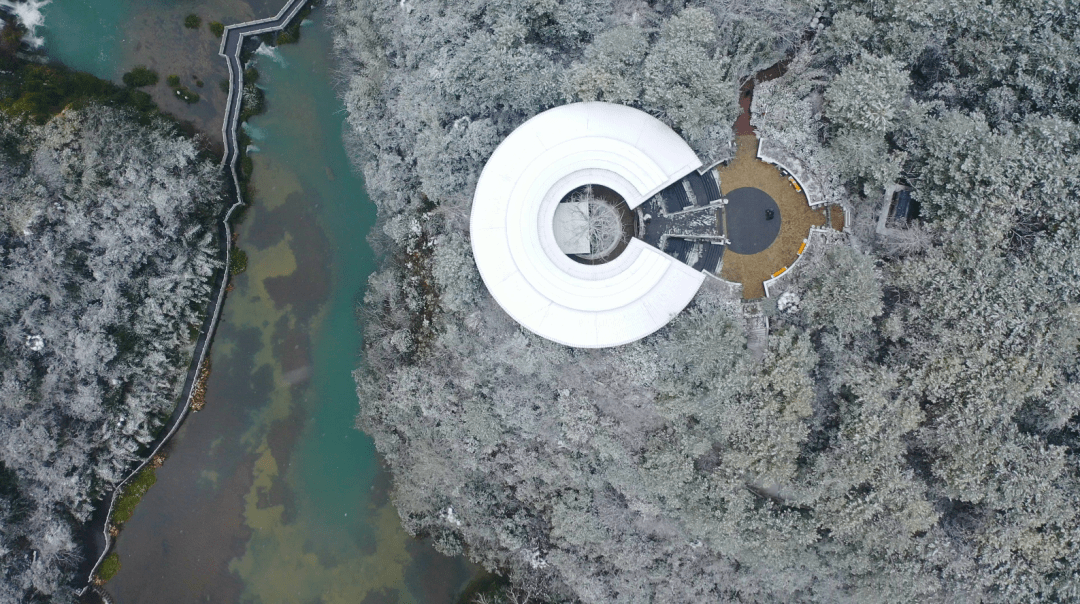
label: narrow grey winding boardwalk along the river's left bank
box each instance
[77,0,308,602]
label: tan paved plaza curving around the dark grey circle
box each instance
[717,135,828,299]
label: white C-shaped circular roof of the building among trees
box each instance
[471,103,705,348]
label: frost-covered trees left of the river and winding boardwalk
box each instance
[0,107,220,602]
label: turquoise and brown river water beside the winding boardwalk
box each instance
[31,0,476,604]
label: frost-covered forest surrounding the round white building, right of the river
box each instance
[337,0,1080,603]
